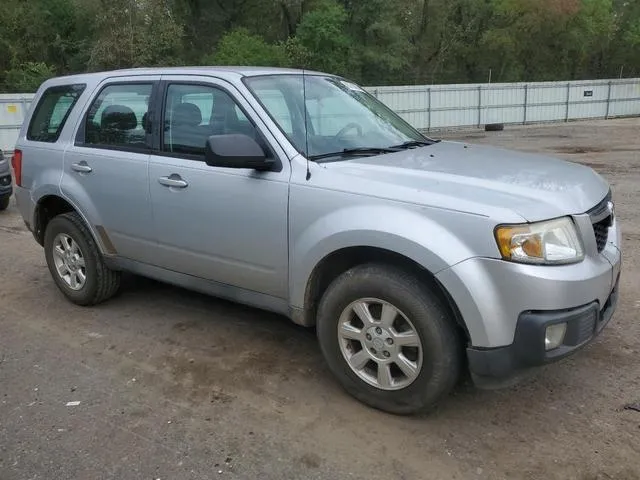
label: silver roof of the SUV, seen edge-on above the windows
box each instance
[44,66,333,83]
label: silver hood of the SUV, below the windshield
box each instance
[322,141,609,221]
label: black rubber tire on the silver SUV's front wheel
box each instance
[317,264,464,415]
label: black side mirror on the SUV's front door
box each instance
[204,134,274,171]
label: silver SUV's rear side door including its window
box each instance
[61,76,160,263]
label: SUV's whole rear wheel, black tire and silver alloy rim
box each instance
[44,212,120,305]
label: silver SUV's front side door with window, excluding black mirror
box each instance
[149,76,290,298]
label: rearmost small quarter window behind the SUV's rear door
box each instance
[27,84,86,143]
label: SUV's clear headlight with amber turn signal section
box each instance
[495,217,584,265]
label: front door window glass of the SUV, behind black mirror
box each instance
[162,83,260,158]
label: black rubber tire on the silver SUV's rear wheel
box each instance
[44,212,120,306]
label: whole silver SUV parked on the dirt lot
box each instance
[13,67,621,413]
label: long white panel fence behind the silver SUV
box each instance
[0,78,640,151]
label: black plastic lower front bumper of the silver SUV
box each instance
[467,277,619,386]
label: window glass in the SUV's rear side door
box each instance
[84,83,153,149]
